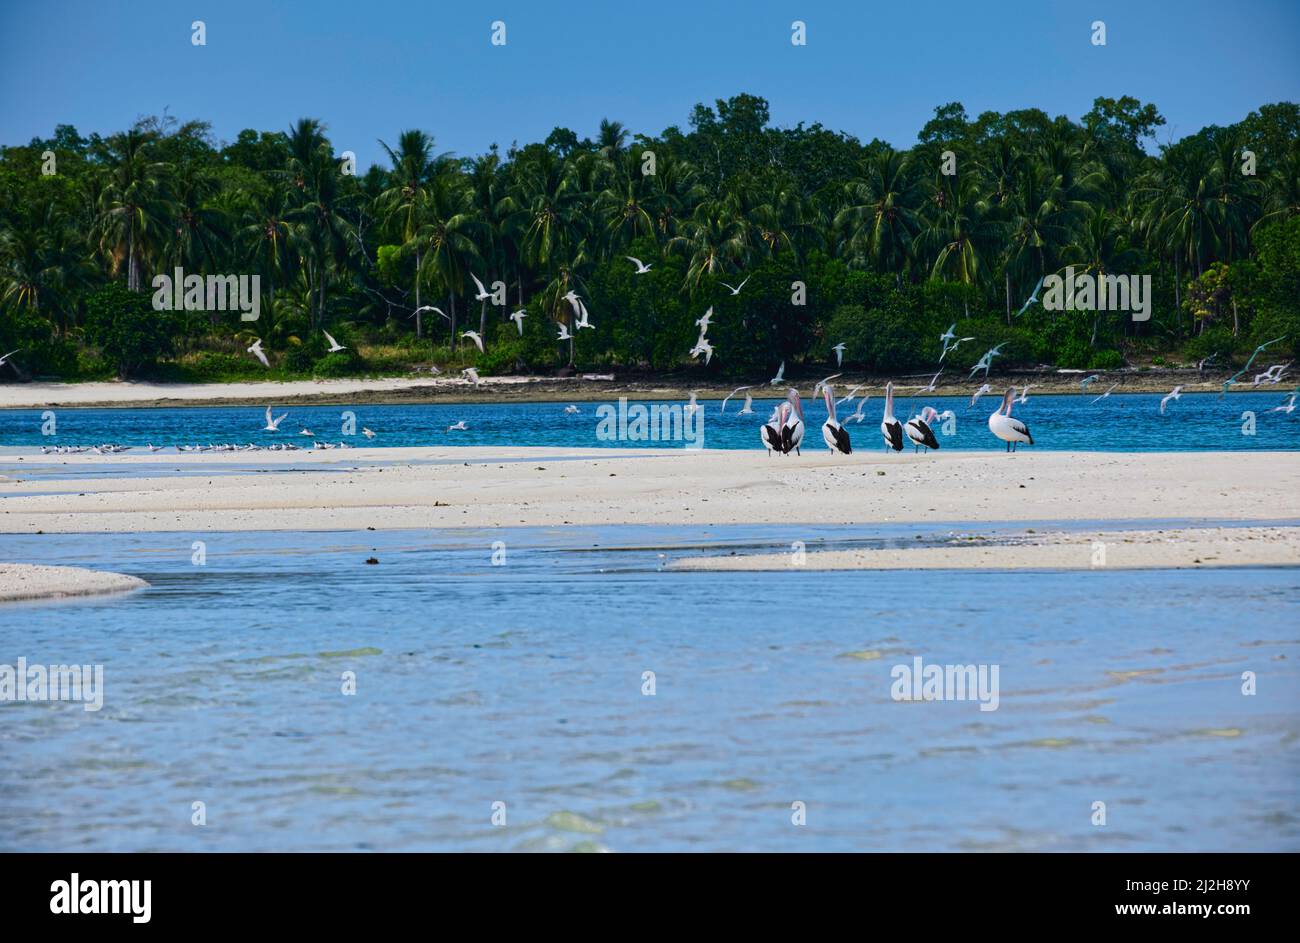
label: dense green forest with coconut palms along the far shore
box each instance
[0,95,1300,381]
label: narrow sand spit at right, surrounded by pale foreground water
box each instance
[670,527,1300,571]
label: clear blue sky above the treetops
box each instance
[0,0,1300,168]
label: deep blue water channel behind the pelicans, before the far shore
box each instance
[0,390,1300,451]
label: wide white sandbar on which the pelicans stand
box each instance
[0,447,1300,533]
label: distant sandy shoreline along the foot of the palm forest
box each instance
[0,367,1294,410]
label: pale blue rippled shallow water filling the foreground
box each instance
[0,523,1300,851]
